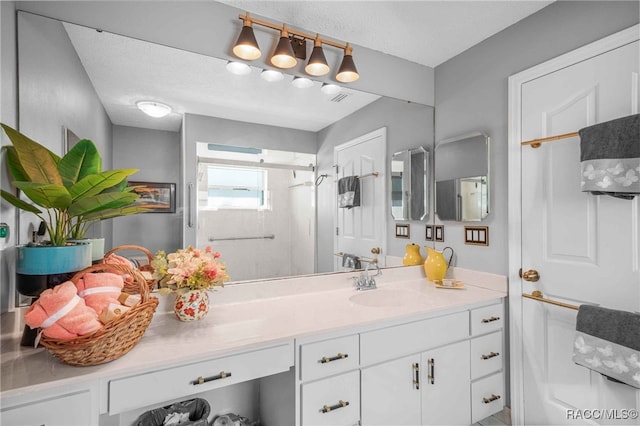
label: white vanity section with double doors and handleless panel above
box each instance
[361,311,471,426]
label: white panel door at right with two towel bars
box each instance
[512,41,640,424]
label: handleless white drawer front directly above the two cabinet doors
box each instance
[360,311,469,365]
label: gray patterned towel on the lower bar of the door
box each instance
[573,305,640,389]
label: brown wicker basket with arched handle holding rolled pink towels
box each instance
[40,264,158,366]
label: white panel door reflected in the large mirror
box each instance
[334,128,387,271]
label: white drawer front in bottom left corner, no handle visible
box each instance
[0,391,98,426]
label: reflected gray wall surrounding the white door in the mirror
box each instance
[317,98,434,272]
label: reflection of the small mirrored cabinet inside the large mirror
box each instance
[391,147,429,220]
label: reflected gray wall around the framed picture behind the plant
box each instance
[113,126,182,254]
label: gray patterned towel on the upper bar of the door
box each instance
[578,114,640,199]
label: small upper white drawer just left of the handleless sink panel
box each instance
[300,335,360,381]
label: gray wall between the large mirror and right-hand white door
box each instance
[435,1,640,274]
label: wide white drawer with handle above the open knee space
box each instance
[109,343,293,414]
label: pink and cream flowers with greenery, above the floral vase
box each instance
[151,246,229,294]
